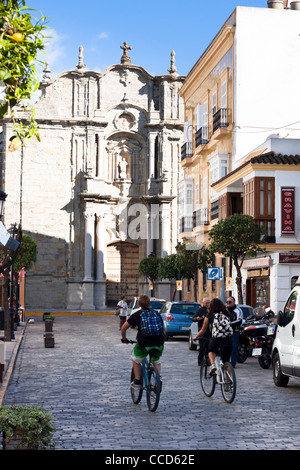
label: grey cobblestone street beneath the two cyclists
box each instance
[4,315,300,452]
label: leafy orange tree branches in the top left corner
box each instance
[0,0,46,151]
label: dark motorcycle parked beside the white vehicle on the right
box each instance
[237,313,277,369]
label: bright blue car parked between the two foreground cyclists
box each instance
[160,302,200,339]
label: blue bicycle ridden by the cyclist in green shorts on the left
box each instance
[121,340,162,411]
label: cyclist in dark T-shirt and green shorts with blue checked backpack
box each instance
[121,295,165,388]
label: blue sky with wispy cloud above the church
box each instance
[26,0,267,78]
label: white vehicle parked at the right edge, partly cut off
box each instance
[272,276,300,387]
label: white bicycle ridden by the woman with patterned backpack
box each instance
[200,346,236,403]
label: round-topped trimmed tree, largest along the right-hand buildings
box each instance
[209,214,265,304]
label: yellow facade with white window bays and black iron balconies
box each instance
[179,17,234,300]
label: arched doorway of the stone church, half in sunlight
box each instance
[106,242,139,306]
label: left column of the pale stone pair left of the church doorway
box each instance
[81,211,95,311]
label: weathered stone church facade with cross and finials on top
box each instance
[1,43,185,311]
